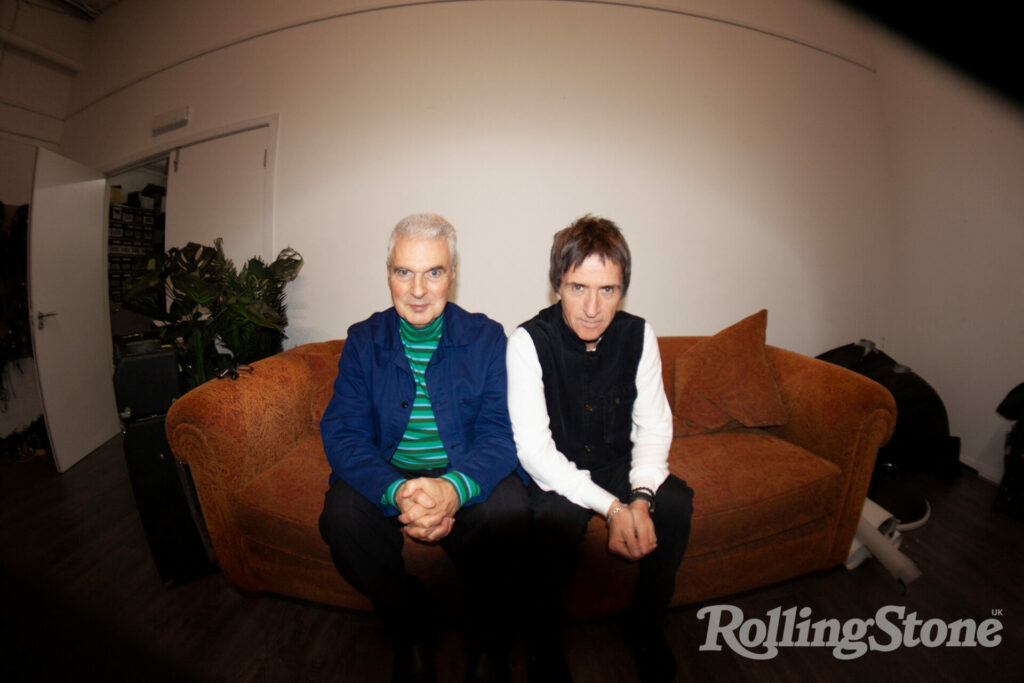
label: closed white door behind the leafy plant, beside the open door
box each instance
[164,126,276,269]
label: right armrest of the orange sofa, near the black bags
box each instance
[768,346,896,566]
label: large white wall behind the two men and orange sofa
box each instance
[51,0,1024,481]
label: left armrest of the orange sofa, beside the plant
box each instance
[167,349,315,589]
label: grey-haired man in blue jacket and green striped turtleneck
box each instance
[319,214,529,681]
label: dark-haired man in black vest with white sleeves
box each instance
[508,215,693,681]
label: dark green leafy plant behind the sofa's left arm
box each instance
[125,238,302,389]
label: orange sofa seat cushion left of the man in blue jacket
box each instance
[234,433,331,558]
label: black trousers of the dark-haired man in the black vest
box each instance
[529,458,693,648]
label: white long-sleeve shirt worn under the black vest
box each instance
[506,322,672,516]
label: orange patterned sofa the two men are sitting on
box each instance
[167,330,896,617]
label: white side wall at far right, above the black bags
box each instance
[879,30,1024,481]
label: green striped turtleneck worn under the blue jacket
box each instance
[381,315,480,507]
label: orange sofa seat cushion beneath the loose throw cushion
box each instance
[669,429,843,556]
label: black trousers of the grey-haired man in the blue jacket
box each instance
[319,473,530,647]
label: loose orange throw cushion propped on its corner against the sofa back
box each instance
[673,309,788,436]
